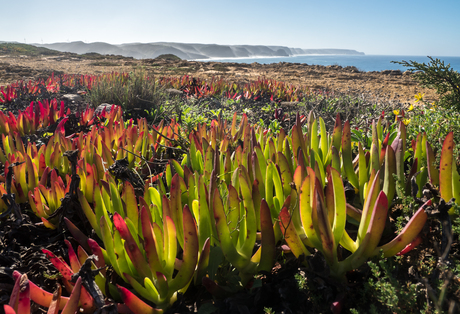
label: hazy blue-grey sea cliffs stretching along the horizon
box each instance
[32,41,364,60]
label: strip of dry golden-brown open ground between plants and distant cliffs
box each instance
[0,54,437,105]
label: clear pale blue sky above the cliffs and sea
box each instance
[0,0,460,56]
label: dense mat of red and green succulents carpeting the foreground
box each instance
[0,73,460,313]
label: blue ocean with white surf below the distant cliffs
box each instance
[200,55,460,72]
